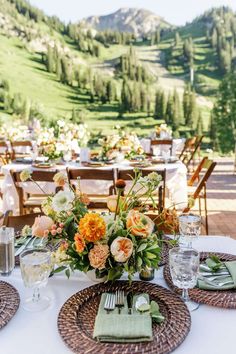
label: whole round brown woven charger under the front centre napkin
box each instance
[58,281,191,354]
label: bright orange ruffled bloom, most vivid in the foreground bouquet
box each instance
[79,213,106,242]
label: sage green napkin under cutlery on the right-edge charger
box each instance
[197,261,236,290]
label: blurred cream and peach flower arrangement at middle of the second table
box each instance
[98,127,144,160]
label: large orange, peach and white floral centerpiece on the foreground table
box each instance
[22,170,168,281]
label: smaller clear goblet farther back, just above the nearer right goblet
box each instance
[179,213,201,248]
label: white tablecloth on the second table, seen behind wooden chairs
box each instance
[2,161,187,214]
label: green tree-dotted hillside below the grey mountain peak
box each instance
[0,0,236,142]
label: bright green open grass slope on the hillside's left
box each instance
[0,35,159,134]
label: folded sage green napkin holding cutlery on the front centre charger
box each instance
[93,293,153,343]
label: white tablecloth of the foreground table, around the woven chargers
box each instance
[0,236,236,354]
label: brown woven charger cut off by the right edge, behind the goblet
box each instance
[164,252,236,309]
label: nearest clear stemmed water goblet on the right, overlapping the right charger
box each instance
[169,247,200,311]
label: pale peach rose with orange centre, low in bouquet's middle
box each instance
[111,236,133,263]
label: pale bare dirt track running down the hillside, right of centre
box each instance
[135,46,213,108]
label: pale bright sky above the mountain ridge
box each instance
[29,0,236,25]
